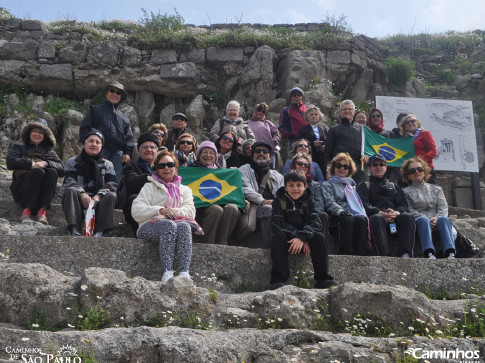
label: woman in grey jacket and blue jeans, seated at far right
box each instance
[401,156,455,260]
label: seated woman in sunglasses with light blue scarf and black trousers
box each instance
[323,153,369,256]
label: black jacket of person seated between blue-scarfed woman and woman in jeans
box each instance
[357,176,408,217]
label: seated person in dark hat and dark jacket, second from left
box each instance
[62,129,118,237]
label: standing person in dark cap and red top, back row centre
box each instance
[278,87,308,150]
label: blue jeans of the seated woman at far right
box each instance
[416,216,455,254]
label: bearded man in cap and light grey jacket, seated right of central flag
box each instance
[237,141,283,248]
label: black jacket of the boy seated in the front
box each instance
[271,187,322,242]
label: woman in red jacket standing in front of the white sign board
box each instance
[399,113,437,184]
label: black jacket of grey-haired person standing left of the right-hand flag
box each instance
[325,118,362,164]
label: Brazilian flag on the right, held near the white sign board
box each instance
[362,126,415,166]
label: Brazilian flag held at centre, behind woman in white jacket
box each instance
[178,167,246,209]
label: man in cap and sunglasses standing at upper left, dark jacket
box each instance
[79,81,134,182]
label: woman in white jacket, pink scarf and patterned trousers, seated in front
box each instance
[131,150,195,282]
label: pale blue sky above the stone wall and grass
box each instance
[0,0,485,38]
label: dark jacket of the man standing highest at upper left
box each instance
[79,101,135,156]
